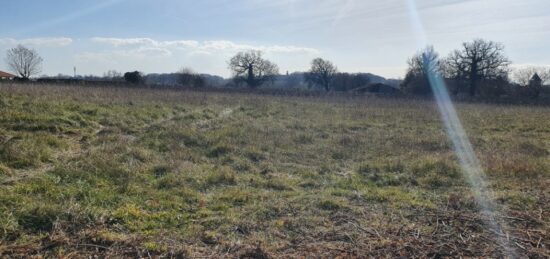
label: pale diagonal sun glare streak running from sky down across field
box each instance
[407,0,517,258]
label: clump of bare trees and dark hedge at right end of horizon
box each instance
[401,39,550,98]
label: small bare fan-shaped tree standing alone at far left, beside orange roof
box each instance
[6,45,42,79]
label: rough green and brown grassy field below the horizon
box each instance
[0,84,550,258]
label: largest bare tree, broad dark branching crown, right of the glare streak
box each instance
[446,39,510,96]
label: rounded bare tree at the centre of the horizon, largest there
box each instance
[229,50,279,88]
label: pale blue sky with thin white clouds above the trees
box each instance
[0,0,550,78]
